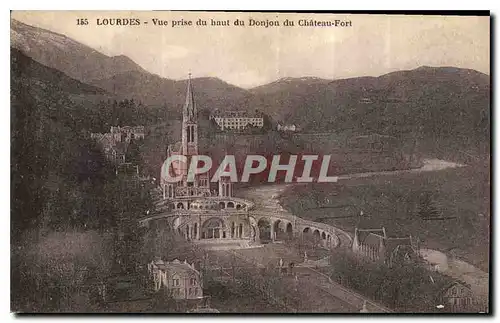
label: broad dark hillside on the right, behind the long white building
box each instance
[246,67,490,160]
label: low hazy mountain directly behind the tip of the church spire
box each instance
[90,71,252,112]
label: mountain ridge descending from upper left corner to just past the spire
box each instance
[11,19,251,111]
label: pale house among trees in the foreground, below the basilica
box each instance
[148,259,203,299]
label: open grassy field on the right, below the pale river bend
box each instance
[281,158,490,271]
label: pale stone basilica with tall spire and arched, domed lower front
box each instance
[158,78,259,246]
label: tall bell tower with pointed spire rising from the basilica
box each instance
[182,73,198,159]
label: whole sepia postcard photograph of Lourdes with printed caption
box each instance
[10,10,493,316]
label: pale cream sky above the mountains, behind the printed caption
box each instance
[11,11,490,88]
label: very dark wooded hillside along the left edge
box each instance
[11,49,117,235]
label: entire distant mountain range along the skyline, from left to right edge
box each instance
[11,16,490,161]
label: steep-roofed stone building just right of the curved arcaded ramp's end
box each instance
[352,227,418,266]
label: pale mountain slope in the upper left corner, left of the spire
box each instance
[10,19,145,82]
